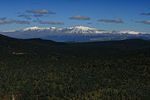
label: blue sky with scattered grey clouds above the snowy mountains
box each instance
[0,0,150,32]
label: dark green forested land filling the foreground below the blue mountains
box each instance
[0,35,150,100]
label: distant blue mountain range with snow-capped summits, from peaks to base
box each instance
[1,26,150,42]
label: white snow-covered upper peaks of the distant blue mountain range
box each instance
[22,26,146,35]
